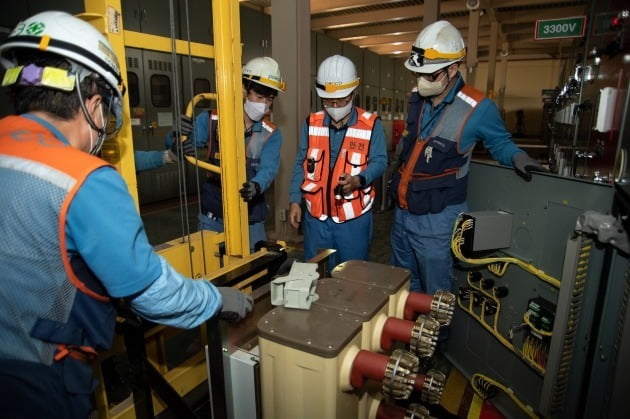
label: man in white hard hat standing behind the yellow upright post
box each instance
[166,57,286,251]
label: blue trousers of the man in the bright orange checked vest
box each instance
[302,211,373,269]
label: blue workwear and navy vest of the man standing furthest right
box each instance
[391,74,523,294]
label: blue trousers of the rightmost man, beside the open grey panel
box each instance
[391,202,468,294]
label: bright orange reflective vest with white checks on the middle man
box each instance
[301,107,378,223]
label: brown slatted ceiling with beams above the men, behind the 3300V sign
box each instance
[240,0,590,61]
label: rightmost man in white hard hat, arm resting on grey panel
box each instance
[390,20,545,294]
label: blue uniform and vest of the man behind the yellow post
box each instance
[166,111,282,251]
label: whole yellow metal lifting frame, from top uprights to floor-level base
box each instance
[79,0,266,418]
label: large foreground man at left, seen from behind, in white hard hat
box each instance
[0,12,252,419]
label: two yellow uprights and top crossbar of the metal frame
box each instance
[81,0,249,257]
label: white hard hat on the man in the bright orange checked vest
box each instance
[315,55,359,99]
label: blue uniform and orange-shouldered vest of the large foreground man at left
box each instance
[0,114,222,418]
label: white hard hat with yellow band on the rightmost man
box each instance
[405,20,466,73]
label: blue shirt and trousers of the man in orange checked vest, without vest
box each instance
[289,107,387,266]
